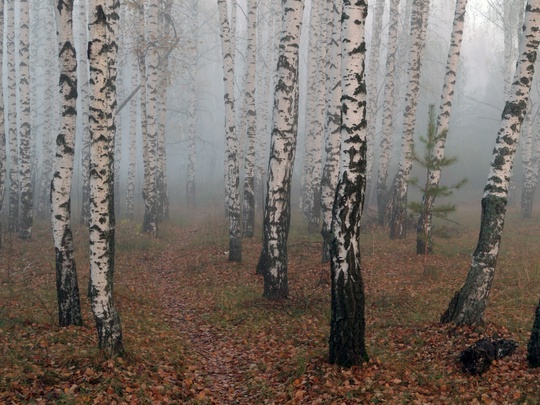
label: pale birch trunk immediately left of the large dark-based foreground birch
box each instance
[321,0,342,263]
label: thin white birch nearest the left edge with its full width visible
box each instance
[5,0,19,233]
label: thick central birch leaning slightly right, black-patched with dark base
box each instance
[257,0,304,299]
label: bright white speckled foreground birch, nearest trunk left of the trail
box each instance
[88,0,124,356]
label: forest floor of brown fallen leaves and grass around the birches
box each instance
[0,207,540,404]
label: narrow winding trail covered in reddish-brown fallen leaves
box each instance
[152,223,262,404]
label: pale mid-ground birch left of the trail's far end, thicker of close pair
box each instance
[142,2,159,236]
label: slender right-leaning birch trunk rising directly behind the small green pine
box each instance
[416,0,467,255]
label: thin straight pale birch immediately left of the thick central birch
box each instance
[241,0,257,238]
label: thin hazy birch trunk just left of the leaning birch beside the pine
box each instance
[377,0,399,226]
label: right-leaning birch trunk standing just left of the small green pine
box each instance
[390,0,429,239]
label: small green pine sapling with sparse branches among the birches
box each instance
[409,104,467,258]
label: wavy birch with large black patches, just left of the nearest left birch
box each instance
[51,0,82,326]
